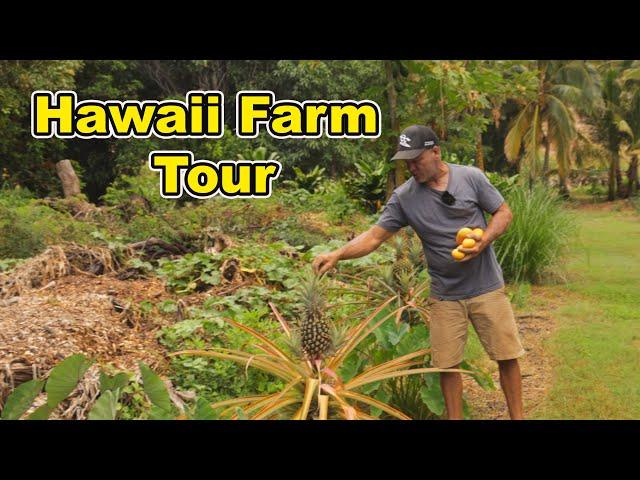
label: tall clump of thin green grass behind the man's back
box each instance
[494,184,576,282]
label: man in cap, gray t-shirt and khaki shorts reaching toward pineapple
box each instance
[313,125,524,420]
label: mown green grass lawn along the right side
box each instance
[533,209,640,419]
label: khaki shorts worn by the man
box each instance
[429,287,524,368]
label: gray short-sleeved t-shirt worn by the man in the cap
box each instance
[377,163,504,300]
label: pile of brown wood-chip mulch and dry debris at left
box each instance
[0,262,175,418]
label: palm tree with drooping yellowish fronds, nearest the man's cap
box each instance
[504,60,600,196]
